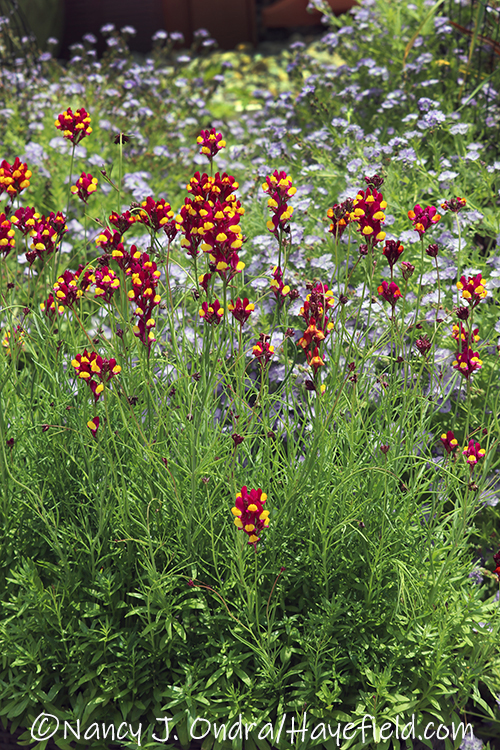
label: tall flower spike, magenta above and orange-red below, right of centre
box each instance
[297,284,335,375]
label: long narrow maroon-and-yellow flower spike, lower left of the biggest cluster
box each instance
[126,250,161,353]
